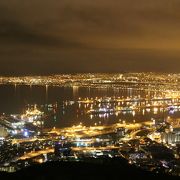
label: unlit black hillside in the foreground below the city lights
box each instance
[0,159,180,180]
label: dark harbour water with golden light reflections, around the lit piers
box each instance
[0,85,180,127]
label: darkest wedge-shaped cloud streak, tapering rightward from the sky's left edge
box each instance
[0,20,86,48]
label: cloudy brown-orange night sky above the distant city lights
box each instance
[0,0,180,75]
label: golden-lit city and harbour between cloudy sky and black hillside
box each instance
[0,73,180,176]
